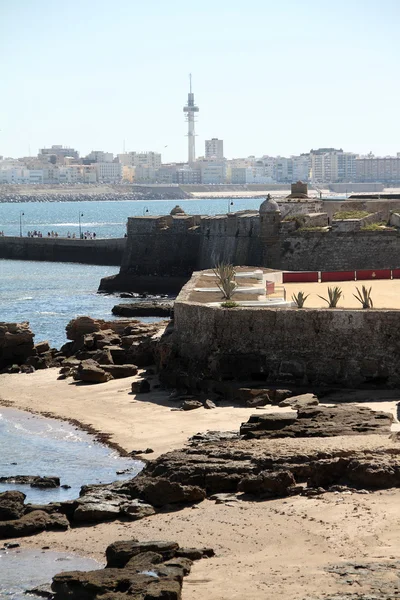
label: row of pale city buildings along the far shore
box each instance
[0,144,400,186]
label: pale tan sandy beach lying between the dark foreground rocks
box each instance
[0,369,400,600]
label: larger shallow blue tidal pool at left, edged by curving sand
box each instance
[0,408,143,504]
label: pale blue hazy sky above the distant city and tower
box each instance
[0,0,400,162]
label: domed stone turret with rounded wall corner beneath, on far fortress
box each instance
[260,194,281,268]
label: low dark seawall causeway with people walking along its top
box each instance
[0,237,126,266]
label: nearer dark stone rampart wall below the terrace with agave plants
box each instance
[160,273,400,389]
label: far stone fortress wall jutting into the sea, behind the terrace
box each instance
[120,199,400,280]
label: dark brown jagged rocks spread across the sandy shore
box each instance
[0,317,400,600]
